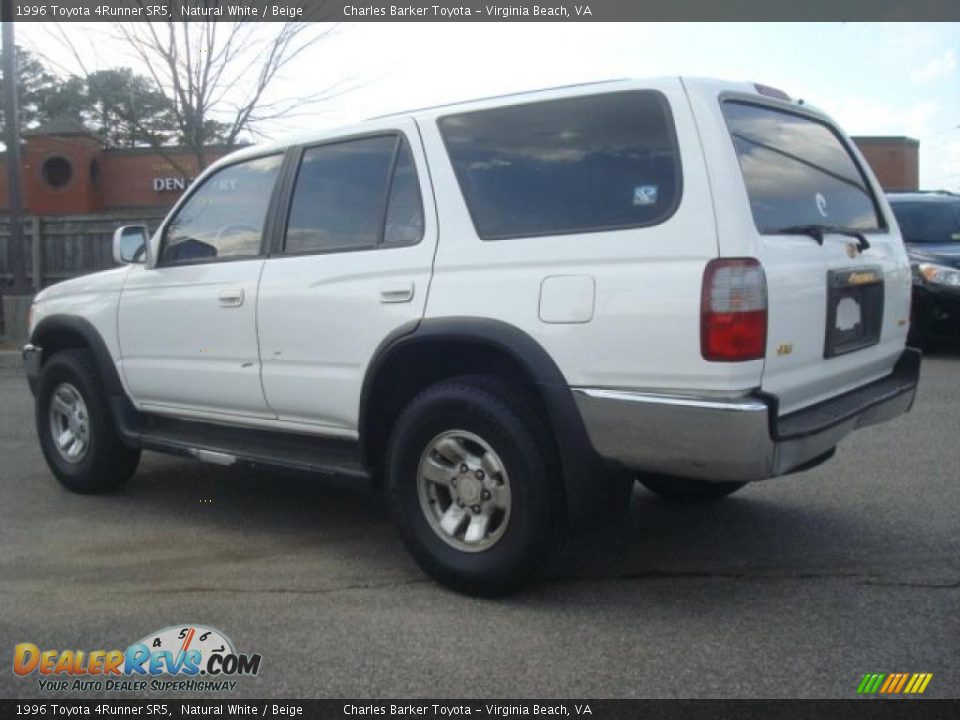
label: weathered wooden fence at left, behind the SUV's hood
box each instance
[0,210,166,334]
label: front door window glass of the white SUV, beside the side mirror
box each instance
[160,155,283,264]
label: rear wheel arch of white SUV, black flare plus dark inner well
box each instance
[359,318,626,529]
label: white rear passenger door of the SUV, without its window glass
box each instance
[258,120,437,430]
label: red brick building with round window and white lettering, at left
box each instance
[0,120,231,215]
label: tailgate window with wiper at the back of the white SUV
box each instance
[722,101,883,233]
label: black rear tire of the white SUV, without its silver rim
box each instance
[385,376,566,597]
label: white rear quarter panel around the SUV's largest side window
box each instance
[421,79,763,394]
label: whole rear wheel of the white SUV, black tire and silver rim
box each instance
[386,376,566,596]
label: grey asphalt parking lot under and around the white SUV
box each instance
[0,352,960,698]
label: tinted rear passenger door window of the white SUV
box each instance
[285,136,423,253]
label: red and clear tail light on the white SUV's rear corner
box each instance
[700,258,767,362]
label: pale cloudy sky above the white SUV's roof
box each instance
[17,22,960,191]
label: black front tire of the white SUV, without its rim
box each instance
[35,350,140,493]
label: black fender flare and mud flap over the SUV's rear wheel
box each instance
[358,317,632,530]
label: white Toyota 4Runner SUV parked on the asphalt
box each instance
[24,78,919,594]
